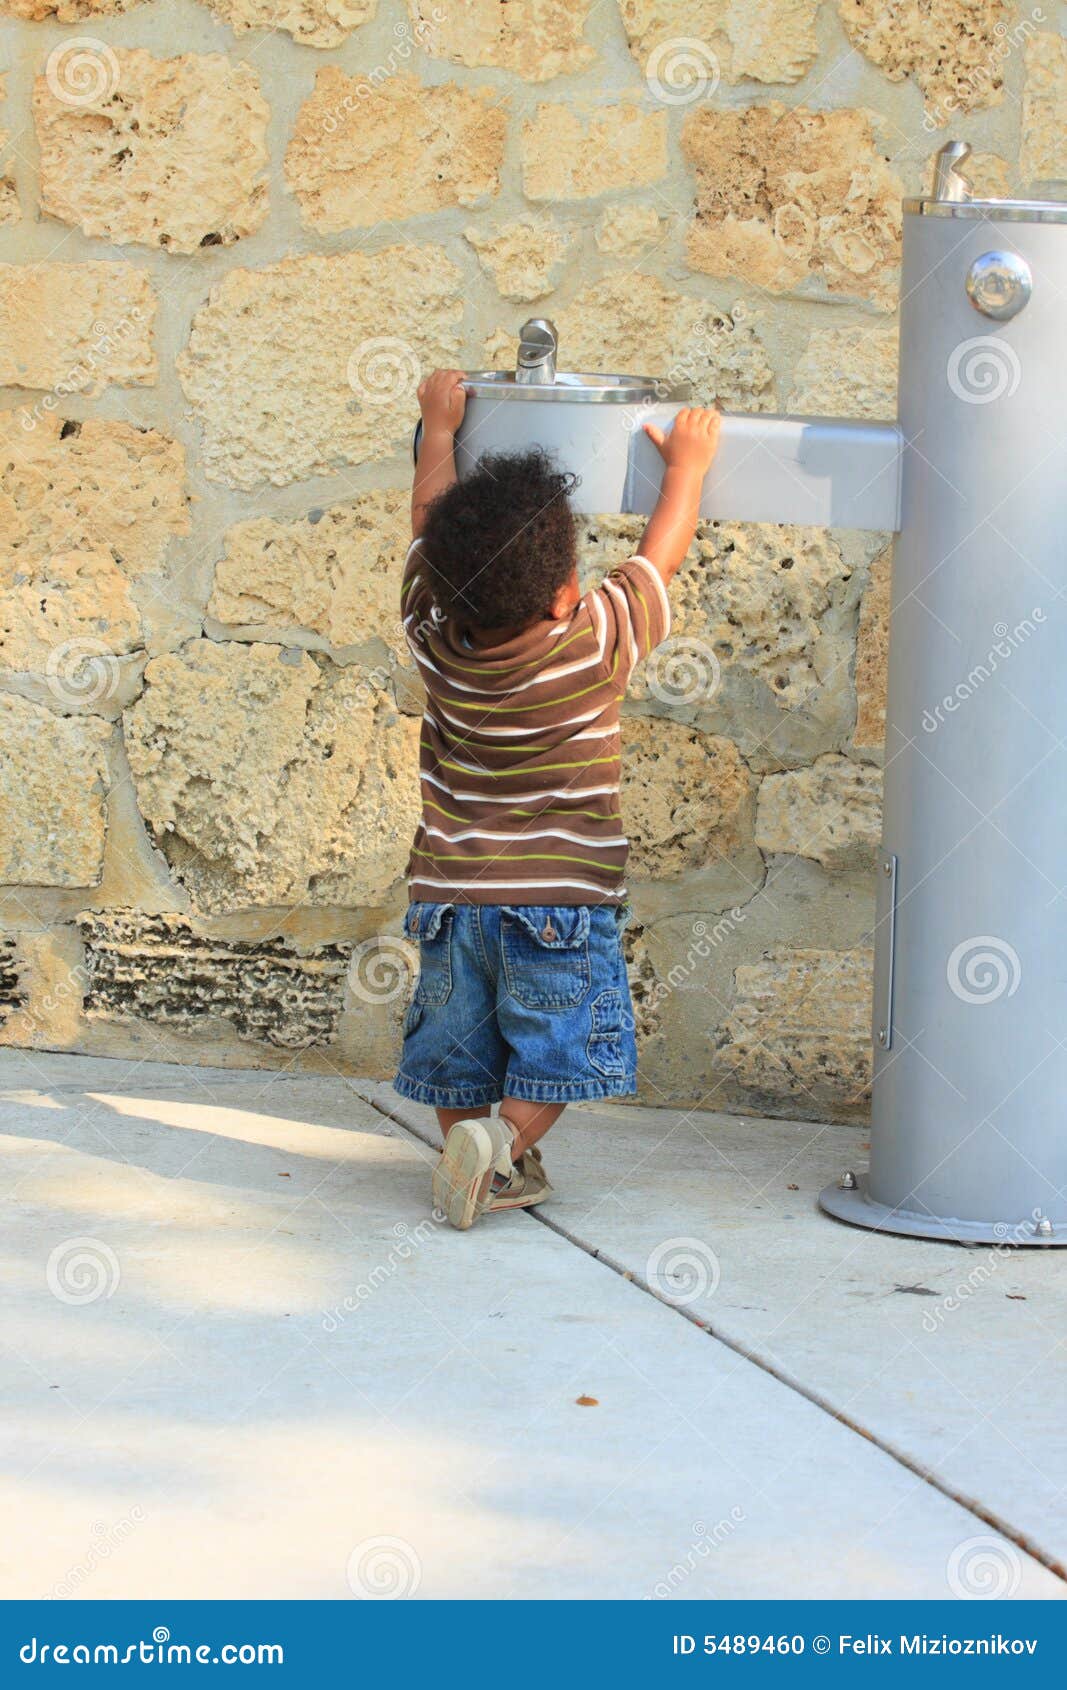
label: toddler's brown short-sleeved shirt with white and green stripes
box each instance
[401,541,670,904]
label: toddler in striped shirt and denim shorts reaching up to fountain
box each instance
[394,370,720,1229]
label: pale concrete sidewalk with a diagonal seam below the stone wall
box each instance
[0,1051,1067,1599]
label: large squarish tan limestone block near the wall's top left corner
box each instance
[32,42,271,252]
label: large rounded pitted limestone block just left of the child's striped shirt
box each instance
[125,641,419,913]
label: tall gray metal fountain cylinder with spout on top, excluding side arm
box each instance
[820,158,1067,1244]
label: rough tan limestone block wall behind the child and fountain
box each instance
[0,0,1067,1119]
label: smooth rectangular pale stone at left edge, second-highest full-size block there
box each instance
[0,264,159,394]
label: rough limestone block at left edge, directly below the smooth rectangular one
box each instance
[0,406,189,585]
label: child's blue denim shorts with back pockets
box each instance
[392,904,637,1109]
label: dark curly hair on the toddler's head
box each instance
[423,448,578,629]
